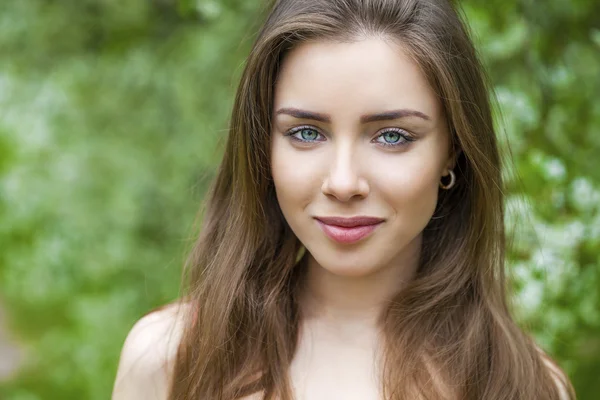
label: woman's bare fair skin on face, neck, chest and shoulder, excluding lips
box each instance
[113,37,568,400]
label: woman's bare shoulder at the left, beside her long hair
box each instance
[112,303,186,400]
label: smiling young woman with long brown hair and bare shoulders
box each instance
[113,0,574,400]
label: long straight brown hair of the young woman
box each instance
[170,0,574,400]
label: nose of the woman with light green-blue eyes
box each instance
[321,145,369,201]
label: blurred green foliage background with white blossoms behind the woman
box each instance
[0,0,600,400]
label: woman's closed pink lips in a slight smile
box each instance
[315,216,384,243]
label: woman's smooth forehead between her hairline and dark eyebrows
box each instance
[275,38,441,119]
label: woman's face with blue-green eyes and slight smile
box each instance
[271,39,452,276]
